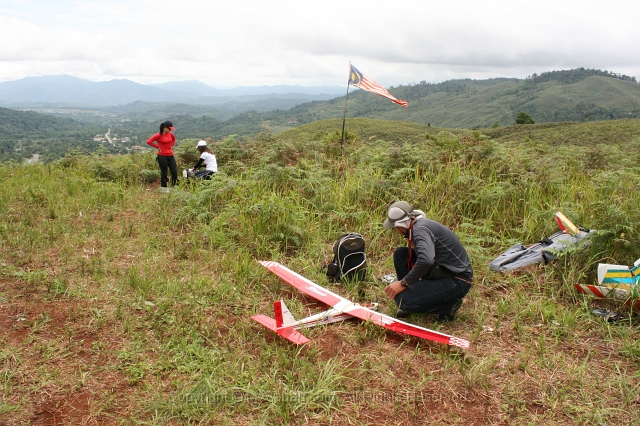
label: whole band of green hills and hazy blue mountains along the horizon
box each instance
[0,68,640,133]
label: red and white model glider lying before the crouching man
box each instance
[251,261,469,349]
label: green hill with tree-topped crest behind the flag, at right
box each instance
[265,69,640,128]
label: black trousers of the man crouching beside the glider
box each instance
[393,247,471,314]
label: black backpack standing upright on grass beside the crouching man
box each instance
[327,232,367,281]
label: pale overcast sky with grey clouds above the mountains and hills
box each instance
[0,0,640,88]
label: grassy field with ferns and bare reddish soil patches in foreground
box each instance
[0,119,640,425]
